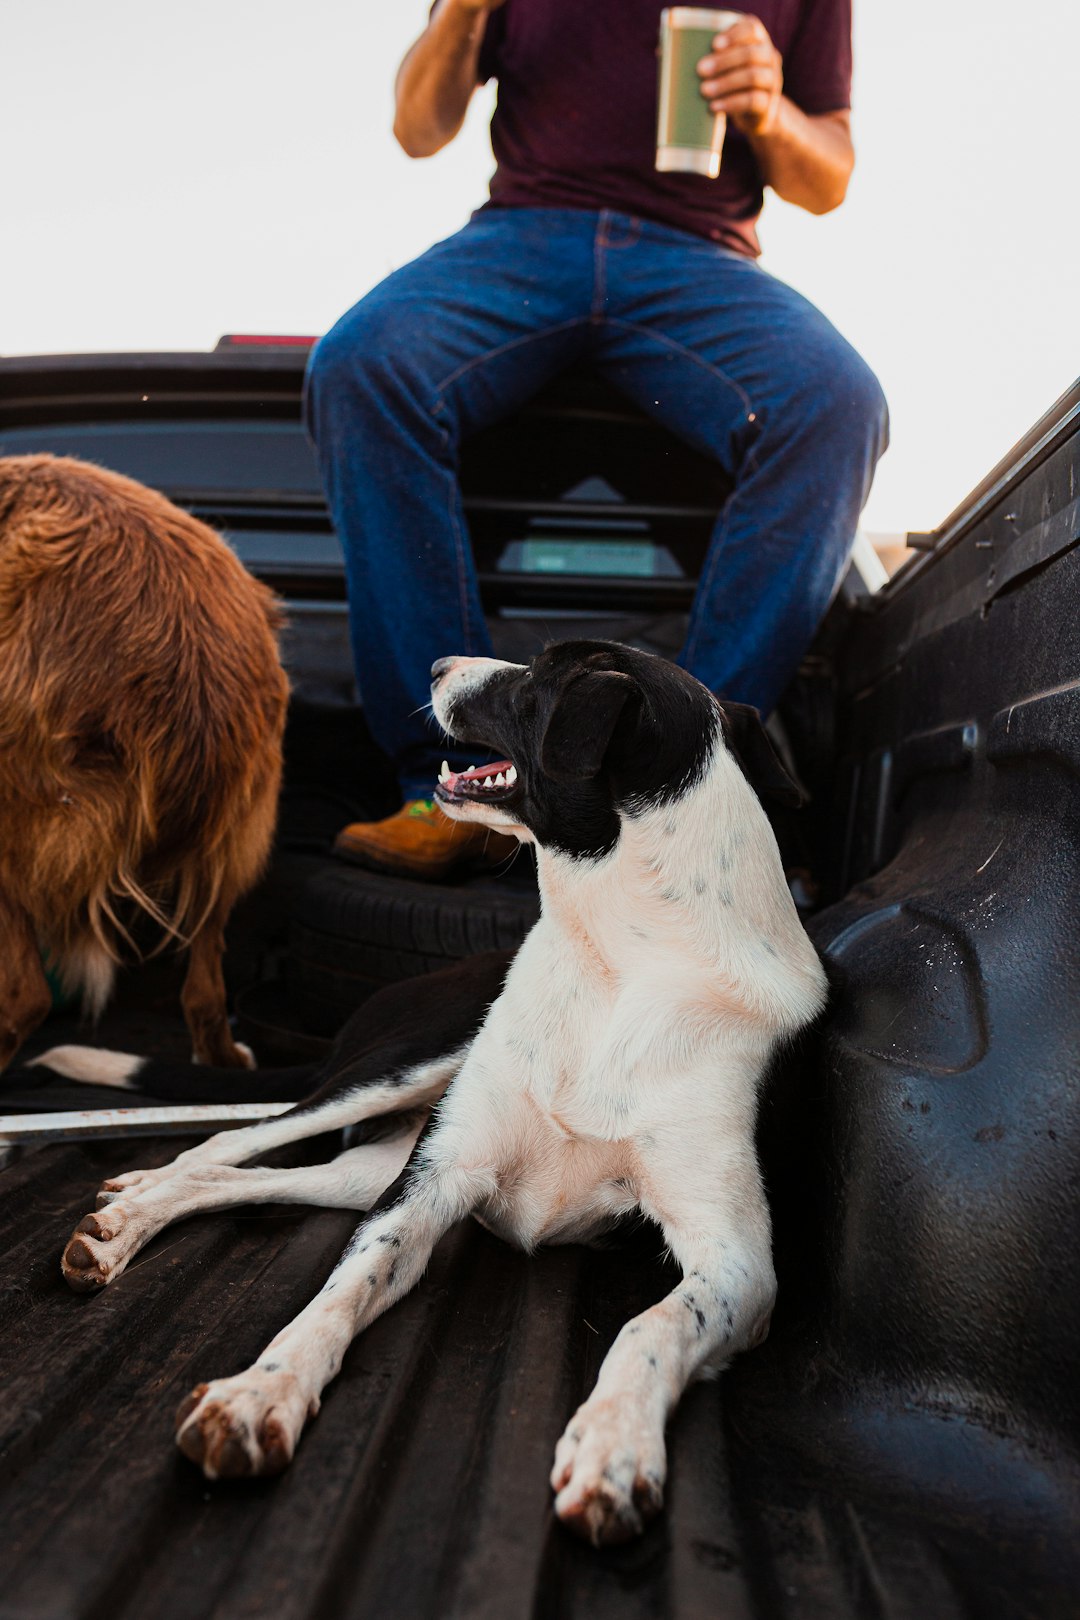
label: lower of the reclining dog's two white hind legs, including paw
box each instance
[60,1123,419,1293]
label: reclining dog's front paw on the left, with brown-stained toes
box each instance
[176,1367,319,1479]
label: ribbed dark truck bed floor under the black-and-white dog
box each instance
[0,991,1067,1620]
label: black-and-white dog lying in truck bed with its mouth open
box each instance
[45,642,826,1544]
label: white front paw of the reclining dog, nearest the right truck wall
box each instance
[551,1395,667,1547]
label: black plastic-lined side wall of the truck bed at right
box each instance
[737,392,1080,1612]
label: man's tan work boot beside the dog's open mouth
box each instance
[334,799,518,883]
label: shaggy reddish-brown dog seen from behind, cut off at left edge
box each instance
[0,455,288,1069]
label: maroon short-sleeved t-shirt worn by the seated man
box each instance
[479,0,852,256]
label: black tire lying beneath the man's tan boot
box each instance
[288,860,539,1029]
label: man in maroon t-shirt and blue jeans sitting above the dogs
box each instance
[308,0,887,878]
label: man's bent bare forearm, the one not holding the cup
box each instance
[393,0,487,157]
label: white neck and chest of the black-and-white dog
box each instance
[481,752,824,1140]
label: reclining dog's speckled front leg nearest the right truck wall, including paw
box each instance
[551,1153,776,1547]
